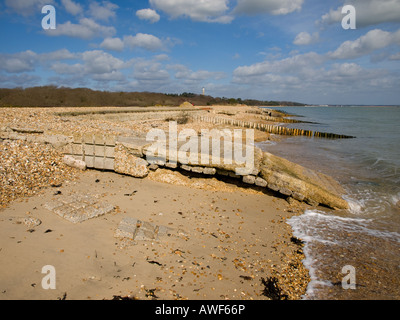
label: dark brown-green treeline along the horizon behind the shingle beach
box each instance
[0,86,303,107]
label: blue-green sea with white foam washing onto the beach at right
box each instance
[257,106,400,300]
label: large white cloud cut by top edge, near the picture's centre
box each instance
[150,0,233,23]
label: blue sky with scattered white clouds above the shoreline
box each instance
[0,0,400,105]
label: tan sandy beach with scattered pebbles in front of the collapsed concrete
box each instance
[0,105,309,300]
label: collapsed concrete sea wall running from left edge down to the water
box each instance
[0,124,348,209]
